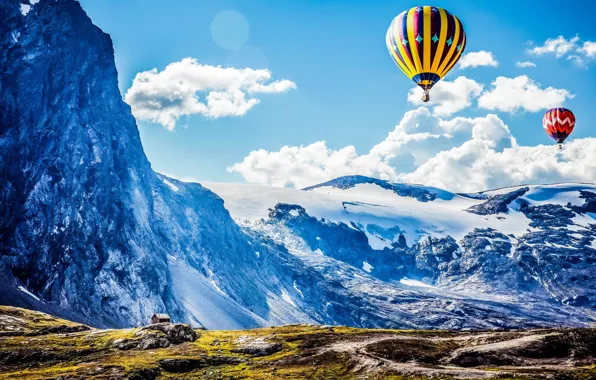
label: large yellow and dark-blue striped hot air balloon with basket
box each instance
[387,6,466,102]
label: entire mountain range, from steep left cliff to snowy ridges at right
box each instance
[0,0,596,328]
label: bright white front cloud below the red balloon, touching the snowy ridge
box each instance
[399,138,596,191]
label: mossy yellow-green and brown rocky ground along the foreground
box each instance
[0,306,596,380]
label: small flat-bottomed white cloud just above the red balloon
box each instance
[478,75,574,113]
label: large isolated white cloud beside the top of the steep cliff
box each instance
[124,58,296,130]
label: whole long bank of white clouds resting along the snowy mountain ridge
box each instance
[228,107,596,192]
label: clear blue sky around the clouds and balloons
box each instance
[80,0,596,190]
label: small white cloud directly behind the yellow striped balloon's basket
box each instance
[408,76,483,116]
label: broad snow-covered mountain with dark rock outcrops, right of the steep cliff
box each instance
[204,176,596,327]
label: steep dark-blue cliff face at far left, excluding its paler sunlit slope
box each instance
[0,1,179,324]
